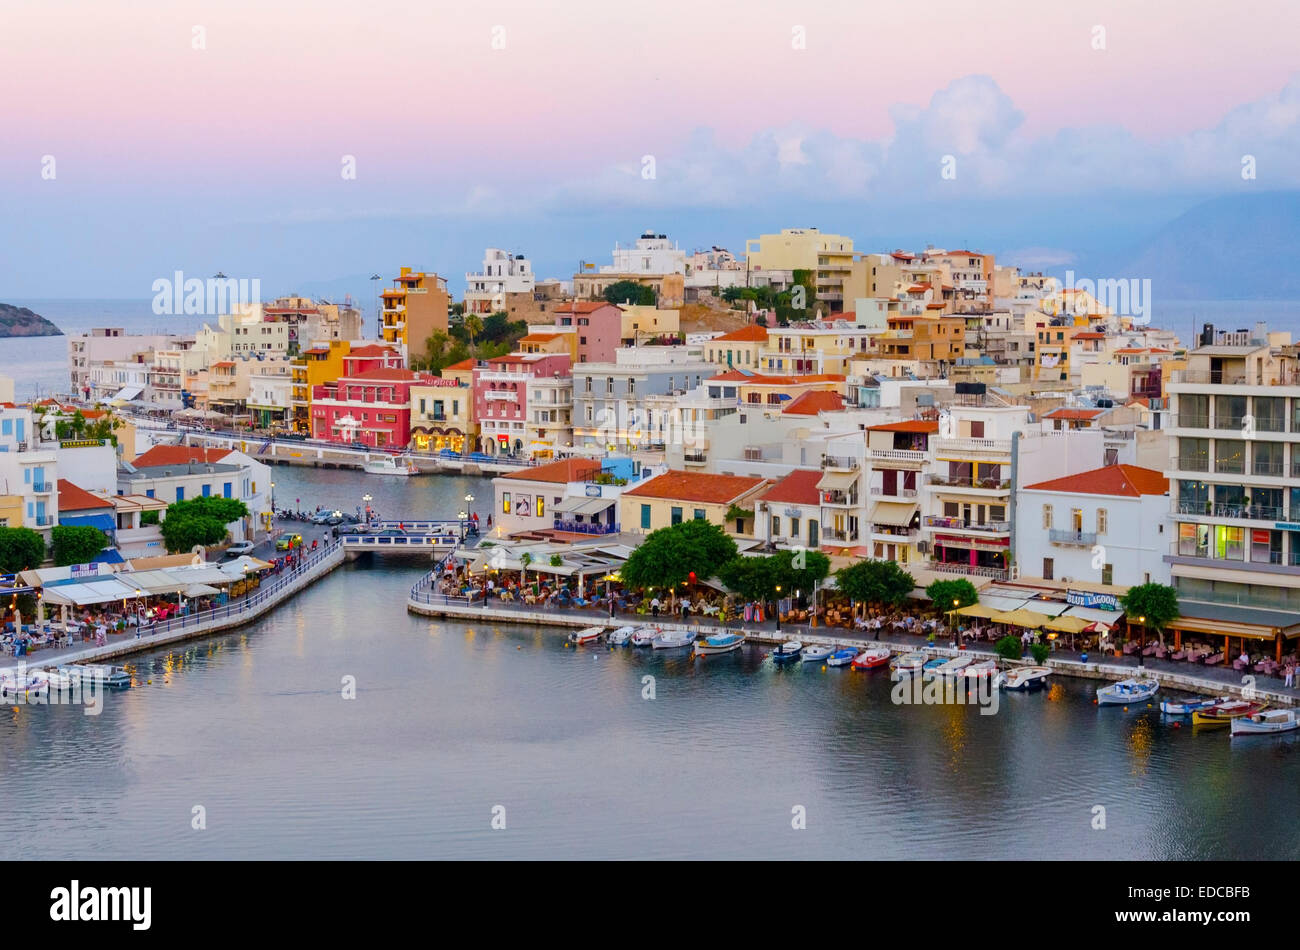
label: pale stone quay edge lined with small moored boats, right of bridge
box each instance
[407,576,1300,706]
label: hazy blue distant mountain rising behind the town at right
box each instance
[1092,192,1300,300]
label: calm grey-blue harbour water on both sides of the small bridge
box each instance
[0,467,1300,860]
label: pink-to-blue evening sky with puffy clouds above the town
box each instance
[0,0,1300,300]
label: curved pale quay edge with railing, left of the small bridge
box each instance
[0,541,346,671]
